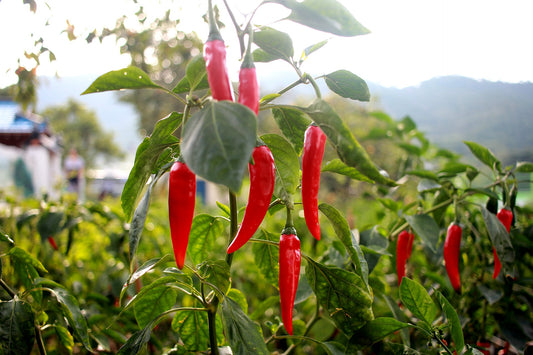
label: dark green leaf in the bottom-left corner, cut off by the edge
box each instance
[0,299,35,355]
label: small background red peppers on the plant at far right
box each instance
[396,207,513,293]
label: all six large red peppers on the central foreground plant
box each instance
[168,1,326,335]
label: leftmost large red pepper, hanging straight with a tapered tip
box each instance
[168,161,196,269]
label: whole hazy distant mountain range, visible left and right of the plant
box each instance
[38,73,533,167]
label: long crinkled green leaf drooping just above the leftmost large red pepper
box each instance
[121,112,183,221]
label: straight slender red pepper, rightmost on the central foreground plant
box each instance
[302,124,326,240]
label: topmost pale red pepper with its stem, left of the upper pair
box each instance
[204,1,233,101]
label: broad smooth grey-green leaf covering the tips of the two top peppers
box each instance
[181,101,256,192]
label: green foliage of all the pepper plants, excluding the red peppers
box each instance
[0,0,520,354]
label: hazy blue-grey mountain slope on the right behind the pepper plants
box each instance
[369,76,533,164]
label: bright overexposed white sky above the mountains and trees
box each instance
[0,0,533,87]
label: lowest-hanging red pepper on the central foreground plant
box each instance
[279,228,302,335]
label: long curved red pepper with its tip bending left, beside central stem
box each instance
[228,145,276,254]
